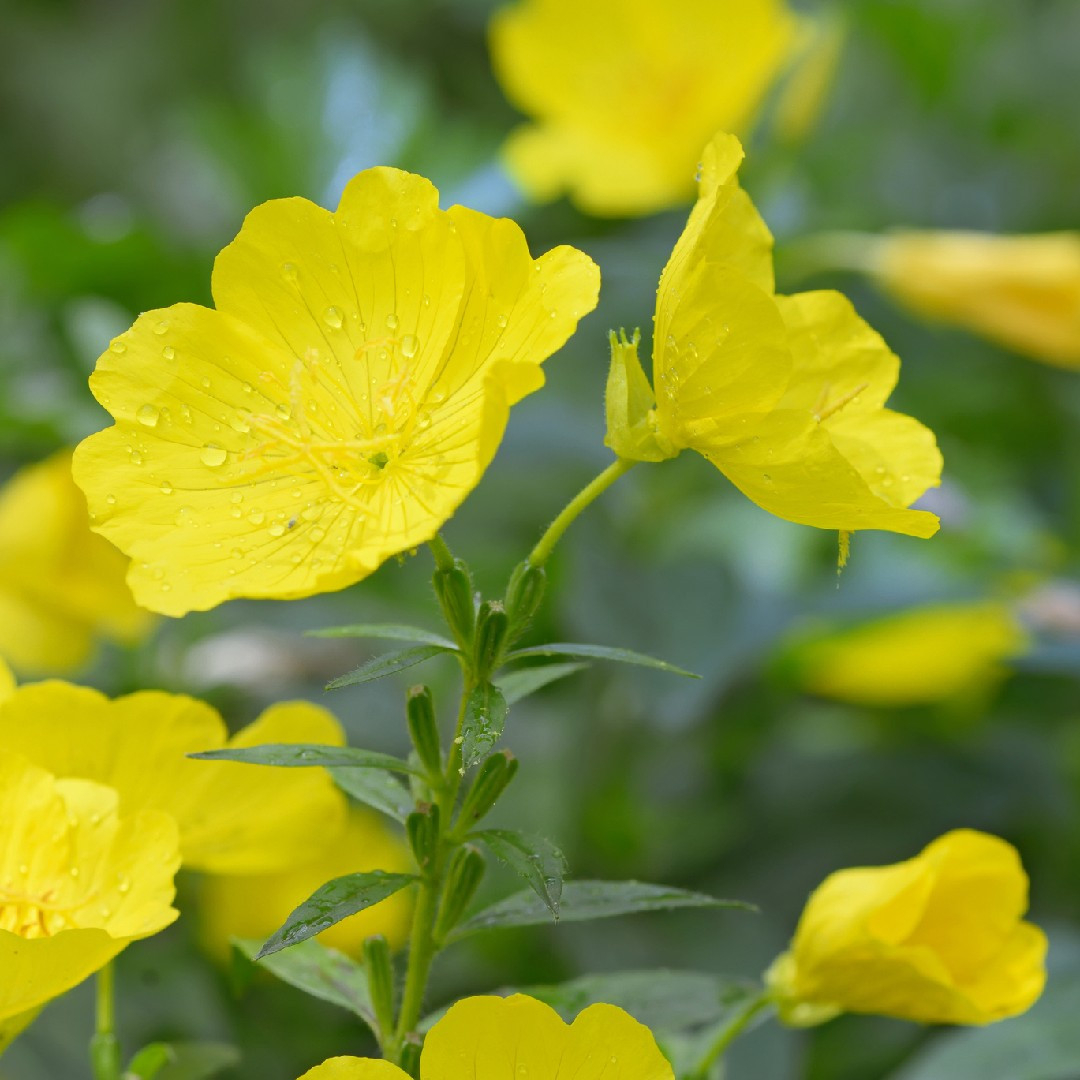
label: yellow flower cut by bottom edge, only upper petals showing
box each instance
[293,994,674,1080]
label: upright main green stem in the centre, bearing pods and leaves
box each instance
[384,677,473,1065]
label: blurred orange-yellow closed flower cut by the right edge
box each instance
[867,231,1080,368]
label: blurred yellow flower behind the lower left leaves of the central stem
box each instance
[200,809,416,959]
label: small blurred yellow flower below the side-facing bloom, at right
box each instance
[792,600,1028,706]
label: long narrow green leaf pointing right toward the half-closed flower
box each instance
[455,881,754,937]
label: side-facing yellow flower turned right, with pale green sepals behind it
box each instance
[607,135,941,537]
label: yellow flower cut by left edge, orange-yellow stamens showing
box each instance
[0,750,179,1023]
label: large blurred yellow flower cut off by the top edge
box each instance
[489,0,798,215]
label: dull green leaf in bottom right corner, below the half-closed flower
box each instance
[890,967,1080,1080]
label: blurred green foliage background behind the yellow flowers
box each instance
[0,0,1080,1080]
